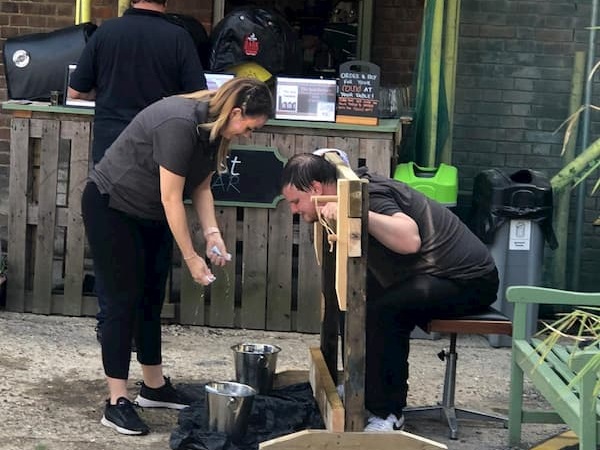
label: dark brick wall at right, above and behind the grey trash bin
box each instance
[453,0,600,291]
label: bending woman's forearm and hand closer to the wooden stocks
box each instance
[192,173,231,266]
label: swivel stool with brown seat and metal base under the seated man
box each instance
[404,307,512,439]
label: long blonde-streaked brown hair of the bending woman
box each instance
[181,77,273,170]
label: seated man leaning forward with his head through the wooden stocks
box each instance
[282,151,498,431]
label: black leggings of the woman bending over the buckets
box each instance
[81,182,173,380]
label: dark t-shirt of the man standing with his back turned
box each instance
[70,8,206,163]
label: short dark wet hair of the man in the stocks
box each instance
[281,153,337,192]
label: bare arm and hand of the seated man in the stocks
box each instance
[321,202,421,255]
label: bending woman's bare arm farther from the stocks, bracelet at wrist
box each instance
[159,166,214,286]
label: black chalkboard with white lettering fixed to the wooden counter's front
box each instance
[211,145,286,208]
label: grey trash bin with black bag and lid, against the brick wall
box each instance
[471,169,558,347]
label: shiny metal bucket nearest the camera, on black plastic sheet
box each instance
[204,381,256,442]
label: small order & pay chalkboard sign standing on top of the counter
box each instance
[336,61,380,125]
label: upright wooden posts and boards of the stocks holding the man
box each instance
[313,153,369,431]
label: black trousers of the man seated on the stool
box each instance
[365,269,498,418]
